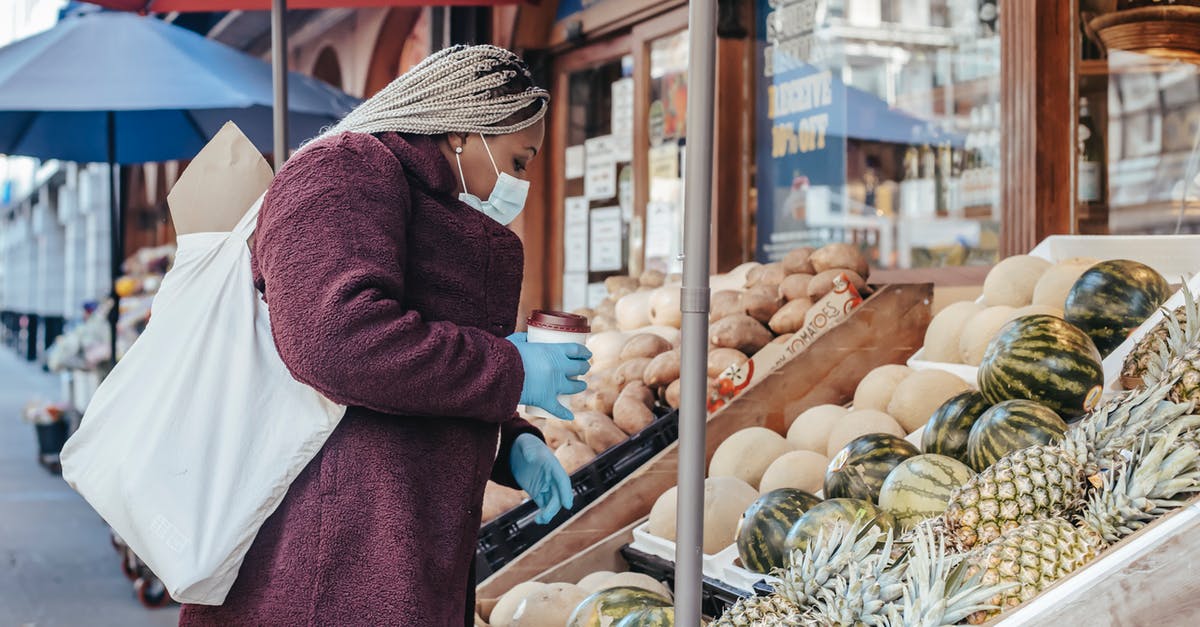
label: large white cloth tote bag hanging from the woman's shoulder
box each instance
[62,197,346,605]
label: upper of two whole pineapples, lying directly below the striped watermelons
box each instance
[943,382,1190,550]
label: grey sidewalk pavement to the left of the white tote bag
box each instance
[0,347,179,627]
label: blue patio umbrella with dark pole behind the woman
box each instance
[0,11,358,358]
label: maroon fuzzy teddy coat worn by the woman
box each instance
[180,133,538,627]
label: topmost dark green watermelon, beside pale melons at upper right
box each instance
[1064,259,1171,356]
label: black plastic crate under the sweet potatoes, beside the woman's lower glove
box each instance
[475,411,679,581]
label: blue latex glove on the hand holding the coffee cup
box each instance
[508,333,592,420]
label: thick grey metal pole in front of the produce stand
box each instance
[674,0,716,627]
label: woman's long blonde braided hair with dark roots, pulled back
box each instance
[322,46,550,137]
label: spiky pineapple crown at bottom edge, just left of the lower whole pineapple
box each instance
[884,526,1018,627]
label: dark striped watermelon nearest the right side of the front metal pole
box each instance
[738,488,821,574]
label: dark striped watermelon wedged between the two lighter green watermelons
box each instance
[824,434,920,503]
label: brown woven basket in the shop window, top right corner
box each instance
[1088,0,1200,64]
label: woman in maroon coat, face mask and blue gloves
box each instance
[180,46,590,627]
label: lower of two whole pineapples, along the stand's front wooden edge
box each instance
[965,417,1200,623]
